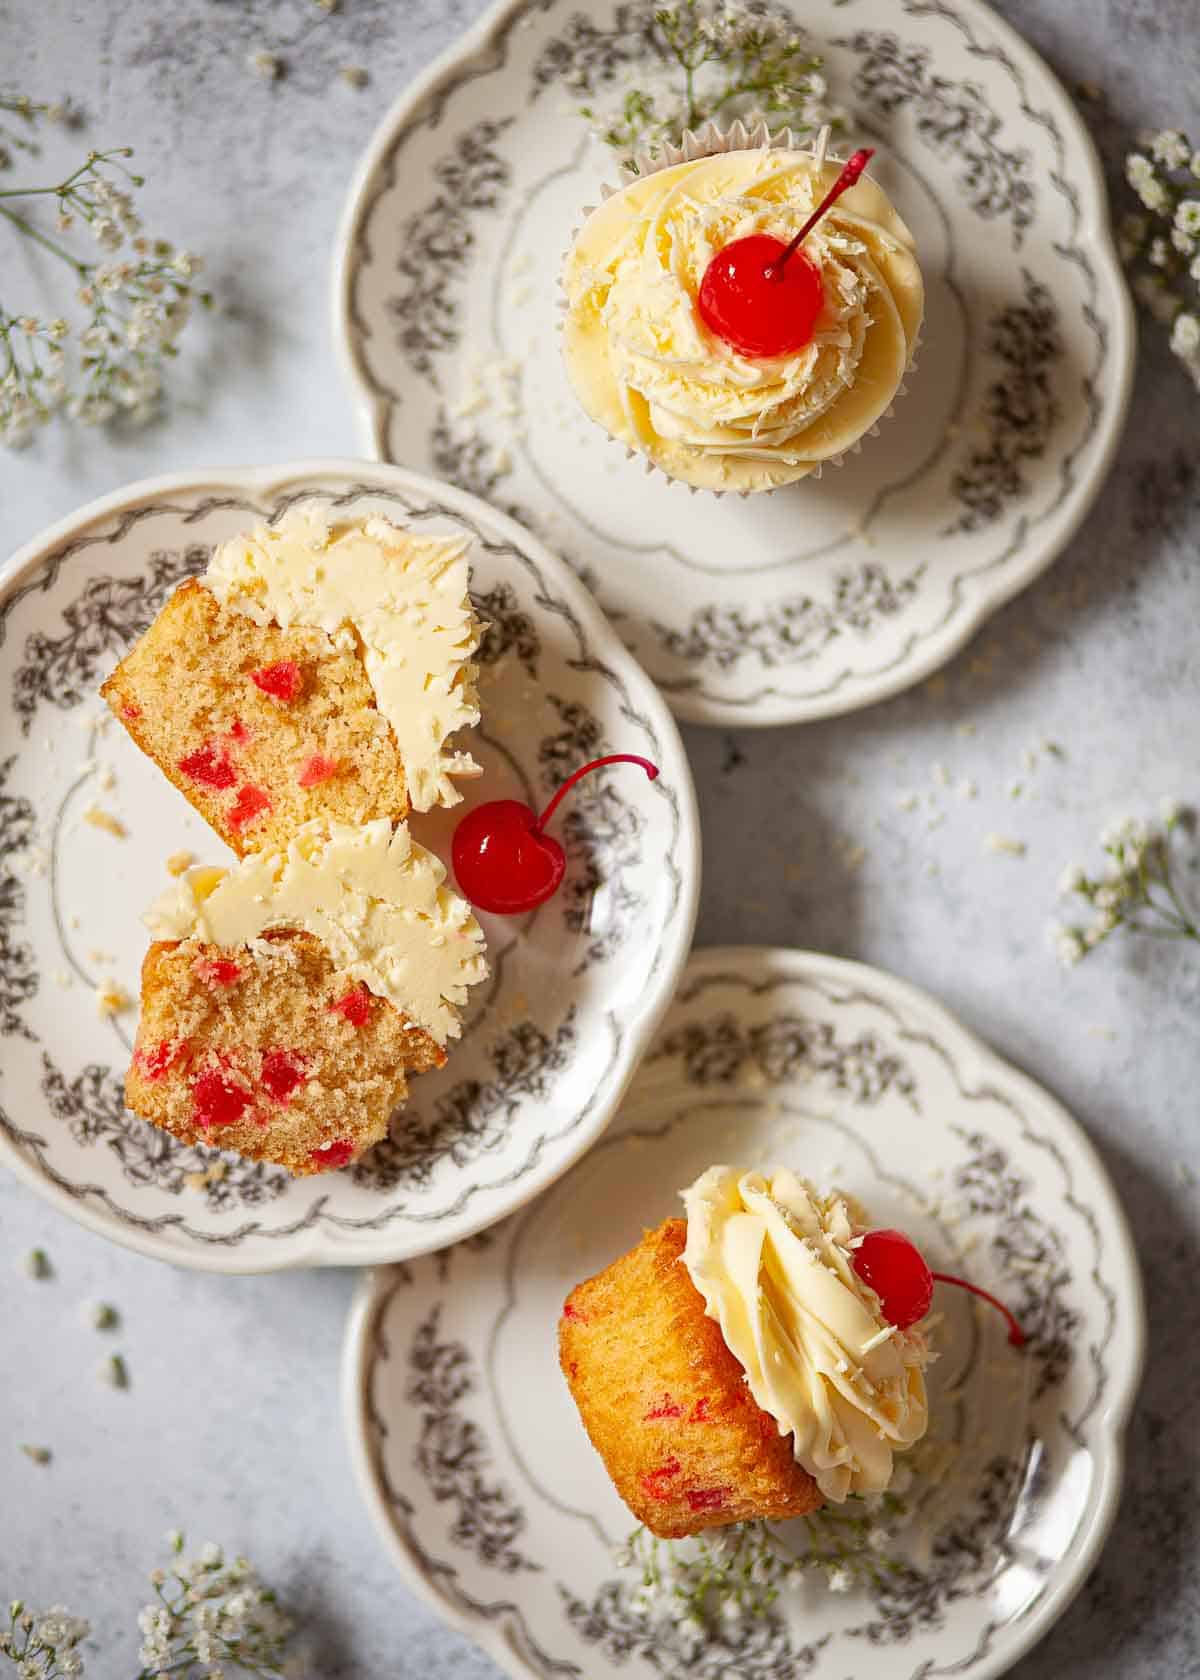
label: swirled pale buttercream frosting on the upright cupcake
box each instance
[563,148,924,491]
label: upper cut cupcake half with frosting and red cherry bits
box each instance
[101,509,482,855]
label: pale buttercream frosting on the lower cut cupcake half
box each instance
[145,818,487,1045]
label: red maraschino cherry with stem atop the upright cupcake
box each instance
[696,146,874,356]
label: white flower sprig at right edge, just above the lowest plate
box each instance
[1050,801,1200,968]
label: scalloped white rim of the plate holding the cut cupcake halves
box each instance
[0,455,703,1275]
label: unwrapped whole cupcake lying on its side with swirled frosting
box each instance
[560,1166,931,1539]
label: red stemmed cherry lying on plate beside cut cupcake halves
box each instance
[450,753,659,916]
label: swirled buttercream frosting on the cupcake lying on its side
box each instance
[682,1166,929,1502]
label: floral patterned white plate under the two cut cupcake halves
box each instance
[0,462,699,1272]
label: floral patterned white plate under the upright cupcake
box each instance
[334,0,1134,724]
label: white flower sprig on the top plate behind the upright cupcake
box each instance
[582,0,829,168]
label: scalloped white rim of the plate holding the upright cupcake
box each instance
[331,0,1138,729]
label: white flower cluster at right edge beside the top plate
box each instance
[1119,128,1200,390]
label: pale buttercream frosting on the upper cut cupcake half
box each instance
[203,506,482,811]
